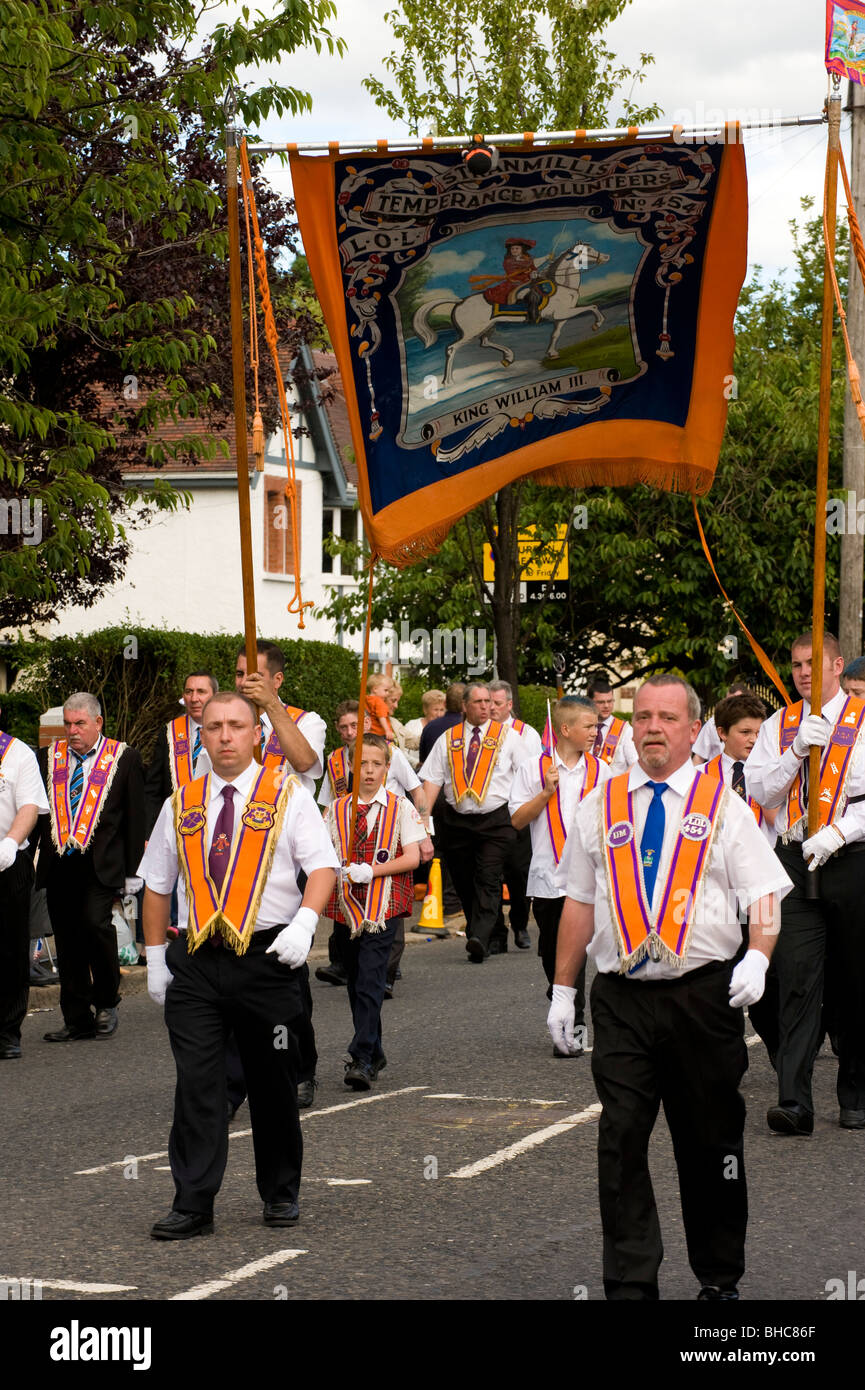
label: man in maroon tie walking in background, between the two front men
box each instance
[420,684,528,965]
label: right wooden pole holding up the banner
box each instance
[805,79,841,898]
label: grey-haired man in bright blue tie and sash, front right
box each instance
[549,676,790,1301]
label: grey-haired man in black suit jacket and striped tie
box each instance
[36,691,145,1043]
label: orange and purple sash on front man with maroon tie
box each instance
[171,767,298,955]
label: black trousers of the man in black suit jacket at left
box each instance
[42,849,122,1030]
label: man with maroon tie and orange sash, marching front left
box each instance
[139,692,338,1240]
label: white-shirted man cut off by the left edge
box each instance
[0,730,49,1062]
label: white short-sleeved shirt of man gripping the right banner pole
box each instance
[745,691,865,842]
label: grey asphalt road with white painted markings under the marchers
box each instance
[6,919,865,1321]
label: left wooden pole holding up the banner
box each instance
[225,97,261,763]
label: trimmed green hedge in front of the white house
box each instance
[6,627,359,759]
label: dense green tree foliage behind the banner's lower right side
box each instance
[328,211,850,701]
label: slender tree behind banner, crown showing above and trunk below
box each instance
[353,0,659,700]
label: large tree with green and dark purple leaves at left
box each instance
[0,0,342,626]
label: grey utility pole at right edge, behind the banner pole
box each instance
[839,82,865,662]
